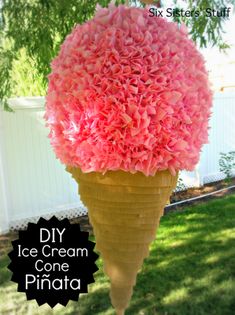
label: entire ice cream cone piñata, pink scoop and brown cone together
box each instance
[44,1,212,315]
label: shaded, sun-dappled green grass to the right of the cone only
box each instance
[126,196,235,315]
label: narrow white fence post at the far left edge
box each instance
[0,109,9,234]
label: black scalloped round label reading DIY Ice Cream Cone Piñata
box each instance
[8,216,98,307]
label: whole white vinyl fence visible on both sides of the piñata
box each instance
[0,92,235,233]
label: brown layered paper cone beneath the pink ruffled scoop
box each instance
[66,167,177,315]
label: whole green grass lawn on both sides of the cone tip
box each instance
[0,195,235,315]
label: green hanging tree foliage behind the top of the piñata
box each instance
[0,0,235,110]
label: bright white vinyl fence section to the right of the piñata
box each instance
[181,92,235,187]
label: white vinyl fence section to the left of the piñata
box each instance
[0,98,86,233]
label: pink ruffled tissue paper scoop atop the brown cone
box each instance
[44,4,212,176]
